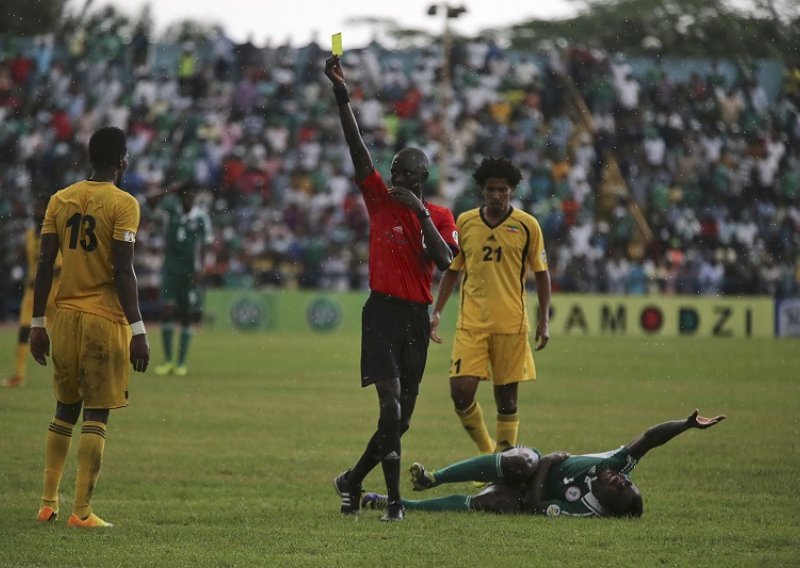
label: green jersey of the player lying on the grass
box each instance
[545,446,637,517]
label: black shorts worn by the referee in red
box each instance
[361,292,431,394]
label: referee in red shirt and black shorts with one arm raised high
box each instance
[325,56,458,521]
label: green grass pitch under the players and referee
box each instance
[0,328,800,567]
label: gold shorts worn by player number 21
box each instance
[450,329,536,385]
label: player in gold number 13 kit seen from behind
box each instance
[31,127,150,528]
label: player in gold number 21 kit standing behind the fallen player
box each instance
[431,158,550,454]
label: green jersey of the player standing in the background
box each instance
[161,195,214,276]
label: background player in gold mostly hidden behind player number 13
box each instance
[3,197,61,387]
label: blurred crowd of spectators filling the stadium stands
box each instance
[0,14,800,317]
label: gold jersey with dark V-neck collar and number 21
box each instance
[450,208,547,334]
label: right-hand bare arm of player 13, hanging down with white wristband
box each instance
[111,239,150,373]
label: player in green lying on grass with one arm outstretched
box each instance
[362,410,725,517]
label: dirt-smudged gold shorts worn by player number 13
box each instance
[50,309,131,408]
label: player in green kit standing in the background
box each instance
[147,181,214,376]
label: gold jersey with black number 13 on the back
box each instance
[42,180,139,323]
